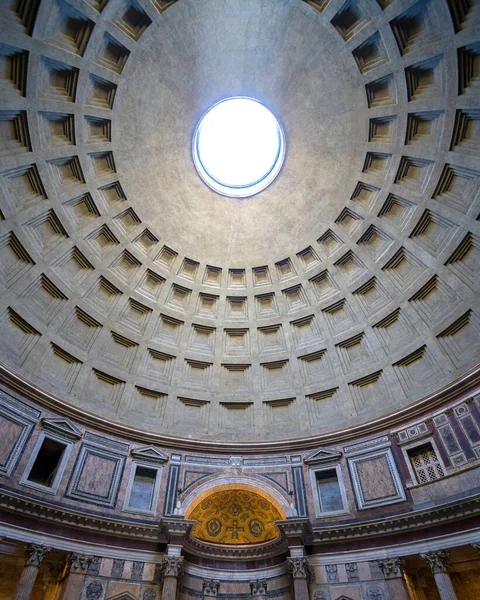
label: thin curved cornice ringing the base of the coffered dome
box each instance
[0,363,480,454]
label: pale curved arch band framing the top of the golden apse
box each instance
[181,475,290,519]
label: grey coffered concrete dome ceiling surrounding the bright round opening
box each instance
[0,0,480,442]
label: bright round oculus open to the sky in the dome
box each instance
[193,97,285,198]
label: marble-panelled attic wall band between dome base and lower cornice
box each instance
[0,378,480,547]
